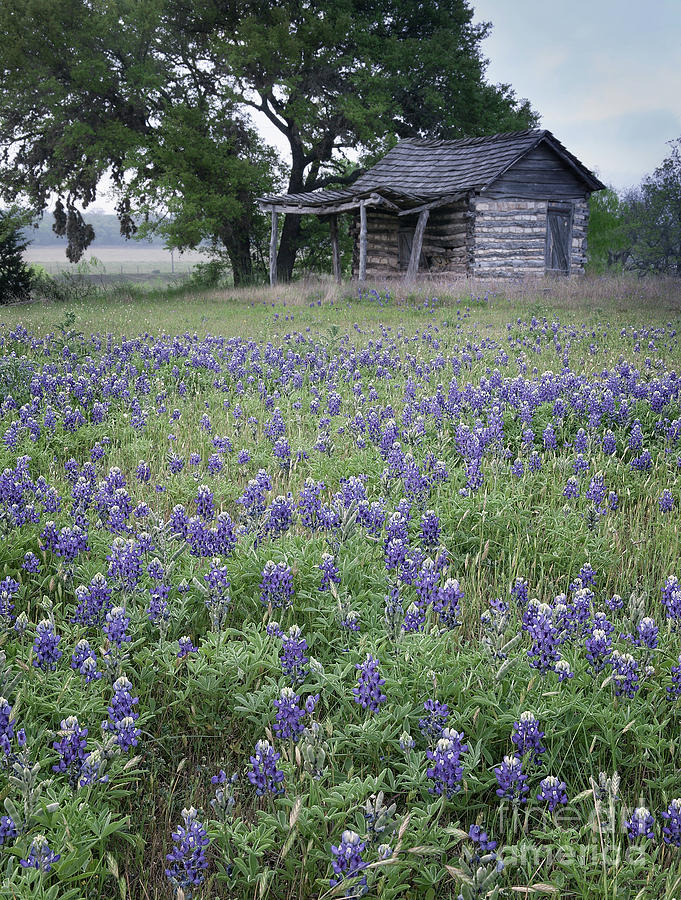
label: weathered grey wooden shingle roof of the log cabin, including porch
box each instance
[260,130,605,212]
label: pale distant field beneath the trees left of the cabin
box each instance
[25,244,207,277]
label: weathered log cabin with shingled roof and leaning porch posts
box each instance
[259,130,605,284]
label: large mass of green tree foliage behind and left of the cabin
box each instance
[0,0,537,283]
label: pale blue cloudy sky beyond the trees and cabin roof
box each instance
[97,0,681,211]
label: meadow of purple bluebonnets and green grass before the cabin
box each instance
[0,278,681,900]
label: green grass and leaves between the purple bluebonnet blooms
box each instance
[0,284,681,900]
